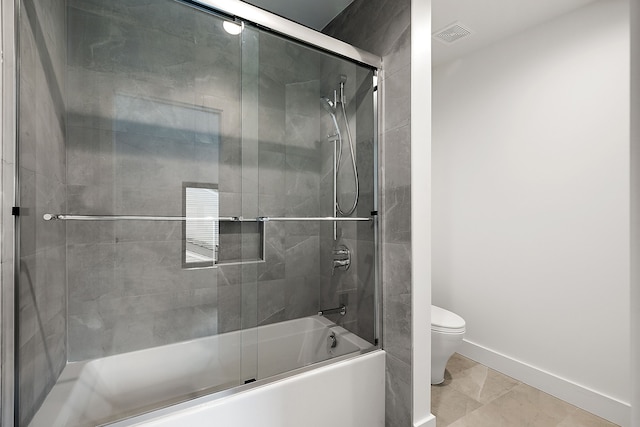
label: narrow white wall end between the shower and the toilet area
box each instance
[411,0,436,427]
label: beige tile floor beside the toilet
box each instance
[431,353,616,427]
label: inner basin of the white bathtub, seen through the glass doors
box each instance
[30,316,384,427]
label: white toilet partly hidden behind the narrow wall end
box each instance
[431,305,465,384]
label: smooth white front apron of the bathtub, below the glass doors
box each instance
[110,350,385,427]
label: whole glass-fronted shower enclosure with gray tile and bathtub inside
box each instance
[15,0,380,426]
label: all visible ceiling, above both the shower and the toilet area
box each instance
[244,0,595,65]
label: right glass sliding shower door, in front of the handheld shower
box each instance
[250,30,377,378]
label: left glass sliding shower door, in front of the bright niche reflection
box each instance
[17,0,262,426]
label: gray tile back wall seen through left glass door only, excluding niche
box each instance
[67,0,243,361]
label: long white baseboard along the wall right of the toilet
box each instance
[458,340,631,427]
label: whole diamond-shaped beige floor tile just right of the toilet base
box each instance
[445,364,520,404]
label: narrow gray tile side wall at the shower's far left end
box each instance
[16,0,67,425]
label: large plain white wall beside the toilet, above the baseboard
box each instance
[432,0,630,424]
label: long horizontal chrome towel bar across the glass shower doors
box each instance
[42,214,373,222]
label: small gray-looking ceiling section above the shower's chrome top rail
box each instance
[243,0,353,31]
